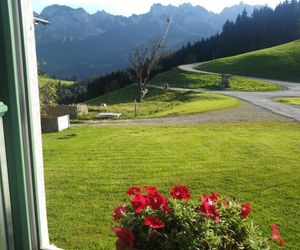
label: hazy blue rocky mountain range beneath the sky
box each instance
[36,2,260,79]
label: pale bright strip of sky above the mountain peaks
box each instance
[32,0,282,16]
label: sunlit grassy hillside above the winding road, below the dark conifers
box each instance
[198,40,300,82]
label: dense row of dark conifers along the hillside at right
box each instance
[162,0,300,70]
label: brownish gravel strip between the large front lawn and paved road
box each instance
[72,102,290,126]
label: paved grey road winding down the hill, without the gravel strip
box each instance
[179,63,300,121]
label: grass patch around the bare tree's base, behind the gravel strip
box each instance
[82,85,240,119]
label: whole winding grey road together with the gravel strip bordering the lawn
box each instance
[72,63,300,126]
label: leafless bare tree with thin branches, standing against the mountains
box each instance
[129,18,172,102]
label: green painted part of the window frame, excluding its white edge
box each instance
[0,0,50,250]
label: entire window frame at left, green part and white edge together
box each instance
[0,0,57,250]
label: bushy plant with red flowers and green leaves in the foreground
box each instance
[113,184,285,250]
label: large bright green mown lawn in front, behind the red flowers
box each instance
[43,122,300,250]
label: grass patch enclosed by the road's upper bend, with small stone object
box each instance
[149,68,282,91]
